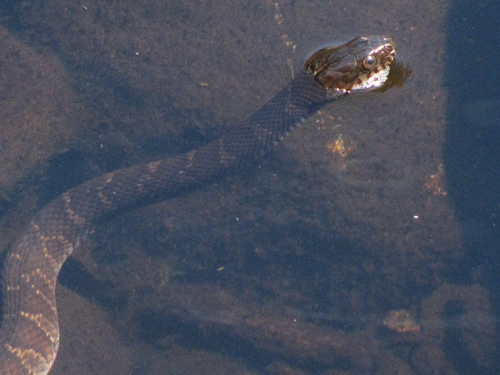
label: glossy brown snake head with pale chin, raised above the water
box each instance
[305,36,396,93]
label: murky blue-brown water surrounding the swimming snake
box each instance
[0,0,499,374]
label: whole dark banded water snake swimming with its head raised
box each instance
[0,35,396,375]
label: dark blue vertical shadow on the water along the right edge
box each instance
[444,0,500,370]
